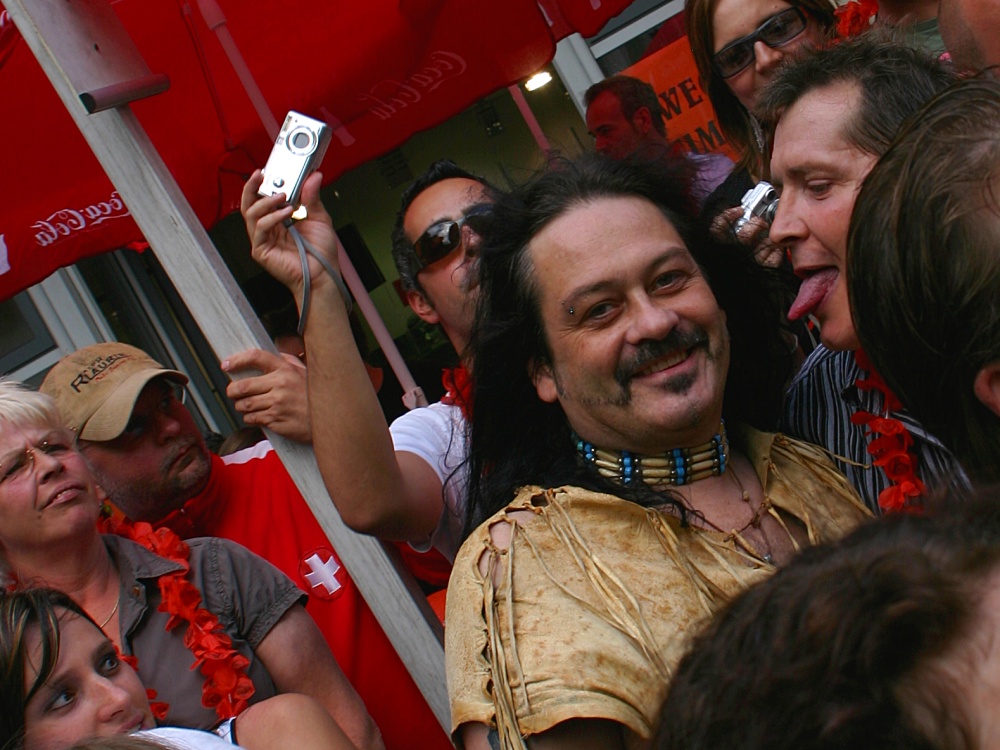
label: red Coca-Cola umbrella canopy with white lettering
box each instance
[0,0,630,300]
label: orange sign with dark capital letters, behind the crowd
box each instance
[622,36,739,161]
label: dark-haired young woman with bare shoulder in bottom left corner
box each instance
[0,589,354,750]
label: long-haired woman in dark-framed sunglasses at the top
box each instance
[684,0,836,219]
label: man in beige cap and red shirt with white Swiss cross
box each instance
[41,343,450,750]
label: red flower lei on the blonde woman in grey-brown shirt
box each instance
[99,509,254,720]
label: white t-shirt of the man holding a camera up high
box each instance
[389,402,469,560]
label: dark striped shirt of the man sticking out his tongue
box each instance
[781,346,968,515]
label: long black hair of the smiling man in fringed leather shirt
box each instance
[465,155,792,535]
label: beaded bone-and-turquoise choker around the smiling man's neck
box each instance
[573,422,729,487]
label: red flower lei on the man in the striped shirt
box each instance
[851,349,925,513]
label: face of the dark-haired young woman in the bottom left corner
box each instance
[24,611,155,750]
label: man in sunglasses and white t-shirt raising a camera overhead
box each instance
[237,160,489,562]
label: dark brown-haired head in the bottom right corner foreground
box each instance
[653,487,1000,750]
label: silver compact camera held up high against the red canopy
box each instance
[257,111,333,207]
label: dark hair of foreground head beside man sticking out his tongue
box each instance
[847,78,1000,482]
